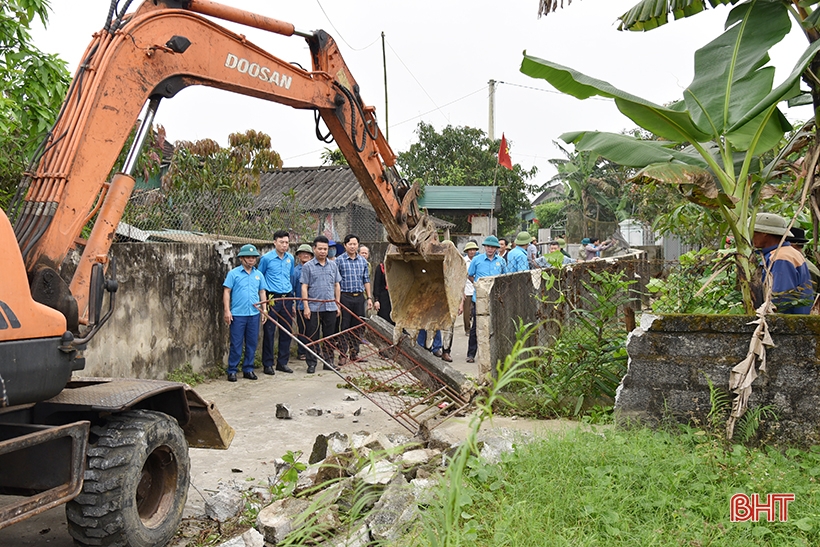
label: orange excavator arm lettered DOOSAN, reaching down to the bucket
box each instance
[6,0,463,338]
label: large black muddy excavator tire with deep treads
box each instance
[66,410,190,547]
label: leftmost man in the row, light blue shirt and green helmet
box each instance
[222,245,267,382]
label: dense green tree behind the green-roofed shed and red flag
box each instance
[398,122,537,234]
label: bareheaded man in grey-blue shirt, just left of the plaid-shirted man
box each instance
[300,236,342,374]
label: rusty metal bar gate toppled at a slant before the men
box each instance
[257,297,470,434]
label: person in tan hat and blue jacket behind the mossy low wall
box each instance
[761,245,814,315]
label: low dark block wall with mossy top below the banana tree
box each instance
[615,315,820,445]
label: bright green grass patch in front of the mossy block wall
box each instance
[411,429,820,547]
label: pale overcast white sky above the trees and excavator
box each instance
[33,0,811,191]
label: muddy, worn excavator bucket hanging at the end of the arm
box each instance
[384,241,467,333]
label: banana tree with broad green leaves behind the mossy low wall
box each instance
[521,0,820,313]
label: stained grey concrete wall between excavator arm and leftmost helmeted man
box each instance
[85,243,231,379]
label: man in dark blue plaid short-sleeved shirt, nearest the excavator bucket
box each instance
[336,234,373,366]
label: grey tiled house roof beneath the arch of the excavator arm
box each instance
[256,165,372,211]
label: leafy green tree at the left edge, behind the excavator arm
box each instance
[0,0,70,207]
